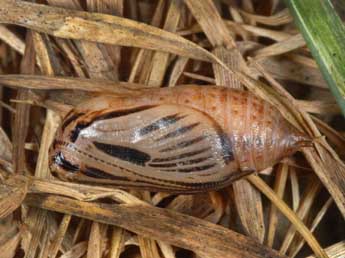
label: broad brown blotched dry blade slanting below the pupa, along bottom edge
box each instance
[26,195,285,258]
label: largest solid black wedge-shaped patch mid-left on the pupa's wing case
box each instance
[93,142,151,166]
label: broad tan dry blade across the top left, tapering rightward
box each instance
[0,0,214,61]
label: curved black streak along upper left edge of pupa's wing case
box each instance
[70,105,156,142]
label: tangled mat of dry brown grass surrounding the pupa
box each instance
[0,0,345,258]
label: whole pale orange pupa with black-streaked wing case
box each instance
[50,86,310,193]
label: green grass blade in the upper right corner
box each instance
[285,0,345,115]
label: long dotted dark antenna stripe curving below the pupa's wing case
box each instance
[59,141,230,191]
